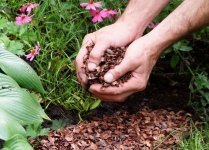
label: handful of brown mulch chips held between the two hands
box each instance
[83,45,132,88]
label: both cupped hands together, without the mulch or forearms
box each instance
[75,23,158,102]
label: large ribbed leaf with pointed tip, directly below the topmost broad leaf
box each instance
[0,88,50,125]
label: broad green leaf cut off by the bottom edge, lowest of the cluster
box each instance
[3,134,33,150]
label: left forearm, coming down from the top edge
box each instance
[117,0,169,38]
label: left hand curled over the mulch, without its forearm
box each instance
[75,22,144,87]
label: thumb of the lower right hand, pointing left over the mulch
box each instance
[104,57,137,83]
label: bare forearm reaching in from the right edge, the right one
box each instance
[148,0,209,55]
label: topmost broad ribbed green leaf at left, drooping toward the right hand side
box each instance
[0,46,45,93]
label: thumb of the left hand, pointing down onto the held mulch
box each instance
[88,41,109,71]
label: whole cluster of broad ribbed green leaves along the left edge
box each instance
[0,47,49,150]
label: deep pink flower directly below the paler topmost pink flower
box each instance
[90,9,109,23]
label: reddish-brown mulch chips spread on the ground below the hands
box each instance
[32,103,194,150]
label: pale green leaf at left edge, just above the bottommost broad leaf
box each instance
[0,109,26,140]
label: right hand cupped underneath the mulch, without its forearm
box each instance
[89,36,159,102]
